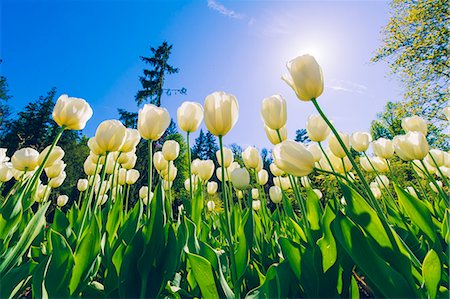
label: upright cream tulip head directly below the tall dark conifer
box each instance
[138,104,171,140]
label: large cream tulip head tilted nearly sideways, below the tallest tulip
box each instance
[272,140,314,176]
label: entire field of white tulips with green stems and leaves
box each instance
[0,55,450,298]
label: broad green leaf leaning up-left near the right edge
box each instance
[394,184,437,243]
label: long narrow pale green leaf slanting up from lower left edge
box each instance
[0,202,50,277]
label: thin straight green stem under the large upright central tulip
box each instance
[219,135,240,298]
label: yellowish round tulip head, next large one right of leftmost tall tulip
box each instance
[95,119,127,153]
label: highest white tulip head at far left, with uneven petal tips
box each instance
[52,94,93,130]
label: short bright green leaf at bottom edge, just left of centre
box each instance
[186,251,220,298]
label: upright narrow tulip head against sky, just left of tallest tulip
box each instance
[261,94,287,131]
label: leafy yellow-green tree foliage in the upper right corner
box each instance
[372,0,450,148]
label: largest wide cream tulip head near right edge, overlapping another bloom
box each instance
[395,132,429,161]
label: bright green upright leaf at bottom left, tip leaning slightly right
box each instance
[69,215,101,296]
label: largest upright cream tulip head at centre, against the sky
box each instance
[204,91,239,136]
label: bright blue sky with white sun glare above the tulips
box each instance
[0,0,401,147]
